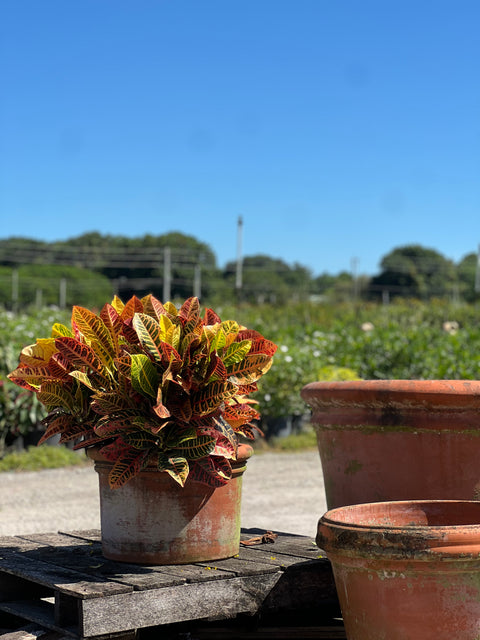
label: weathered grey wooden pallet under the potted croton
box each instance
[0,529,342,639]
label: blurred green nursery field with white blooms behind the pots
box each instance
[0,300,480,455]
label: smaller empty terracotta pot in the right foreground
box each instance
[317,500,480,640]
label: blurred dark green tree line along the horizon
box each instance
[0,232,480,309]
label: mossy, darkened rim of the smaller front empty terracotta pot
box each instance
[317,500,480,561]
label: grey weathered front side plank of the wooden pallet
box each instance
[81,572,281,636]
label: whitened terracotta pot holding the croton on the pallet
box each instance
[87,445,253,564]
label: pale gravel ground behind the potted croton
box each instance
[0,451,326,537]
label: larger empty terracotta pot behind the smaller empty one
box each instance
[302,380,480,509]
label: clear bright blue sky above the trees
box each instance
[0,0,480,275]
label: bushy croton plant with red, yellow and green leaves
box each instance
[9,295,276,489]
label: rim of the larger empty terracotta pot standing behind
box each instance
[301,380,480,408]
